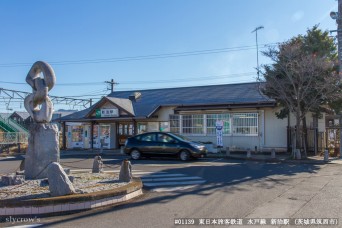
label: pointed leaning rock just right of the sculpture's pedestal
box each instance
[47,162,76,196]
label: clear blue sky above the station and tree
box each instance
[0,0,337,112]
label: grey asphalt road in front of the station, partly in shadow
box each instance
[0,157,342,227]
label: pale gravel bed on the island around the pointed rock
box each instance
[0,173,127,200]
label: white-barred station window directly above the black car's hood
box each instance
[182,115,204,135]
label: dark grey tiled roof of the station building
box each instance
[61,83,275,120]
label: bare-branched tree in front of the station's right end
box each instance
[262,38,341,156]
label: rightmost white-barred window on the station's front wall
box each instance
[233,113,258,135]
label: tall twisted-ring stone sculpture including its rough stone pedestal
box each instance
[24,61,59,179]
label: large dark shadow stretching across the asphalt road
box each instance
[39,159,321,226]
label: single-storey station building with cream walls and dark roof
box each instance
[59,83,325,150]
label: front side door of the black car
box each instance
[157,133,179,155]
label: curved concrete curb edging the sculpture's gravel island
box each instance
[0,178,143,216]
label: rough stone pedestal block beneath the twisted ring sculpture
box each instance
[25,123,59,179]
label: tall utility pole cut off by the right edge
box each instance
[330,0,342,158]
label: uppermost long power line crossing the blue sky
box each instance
[0,43,277,67]
